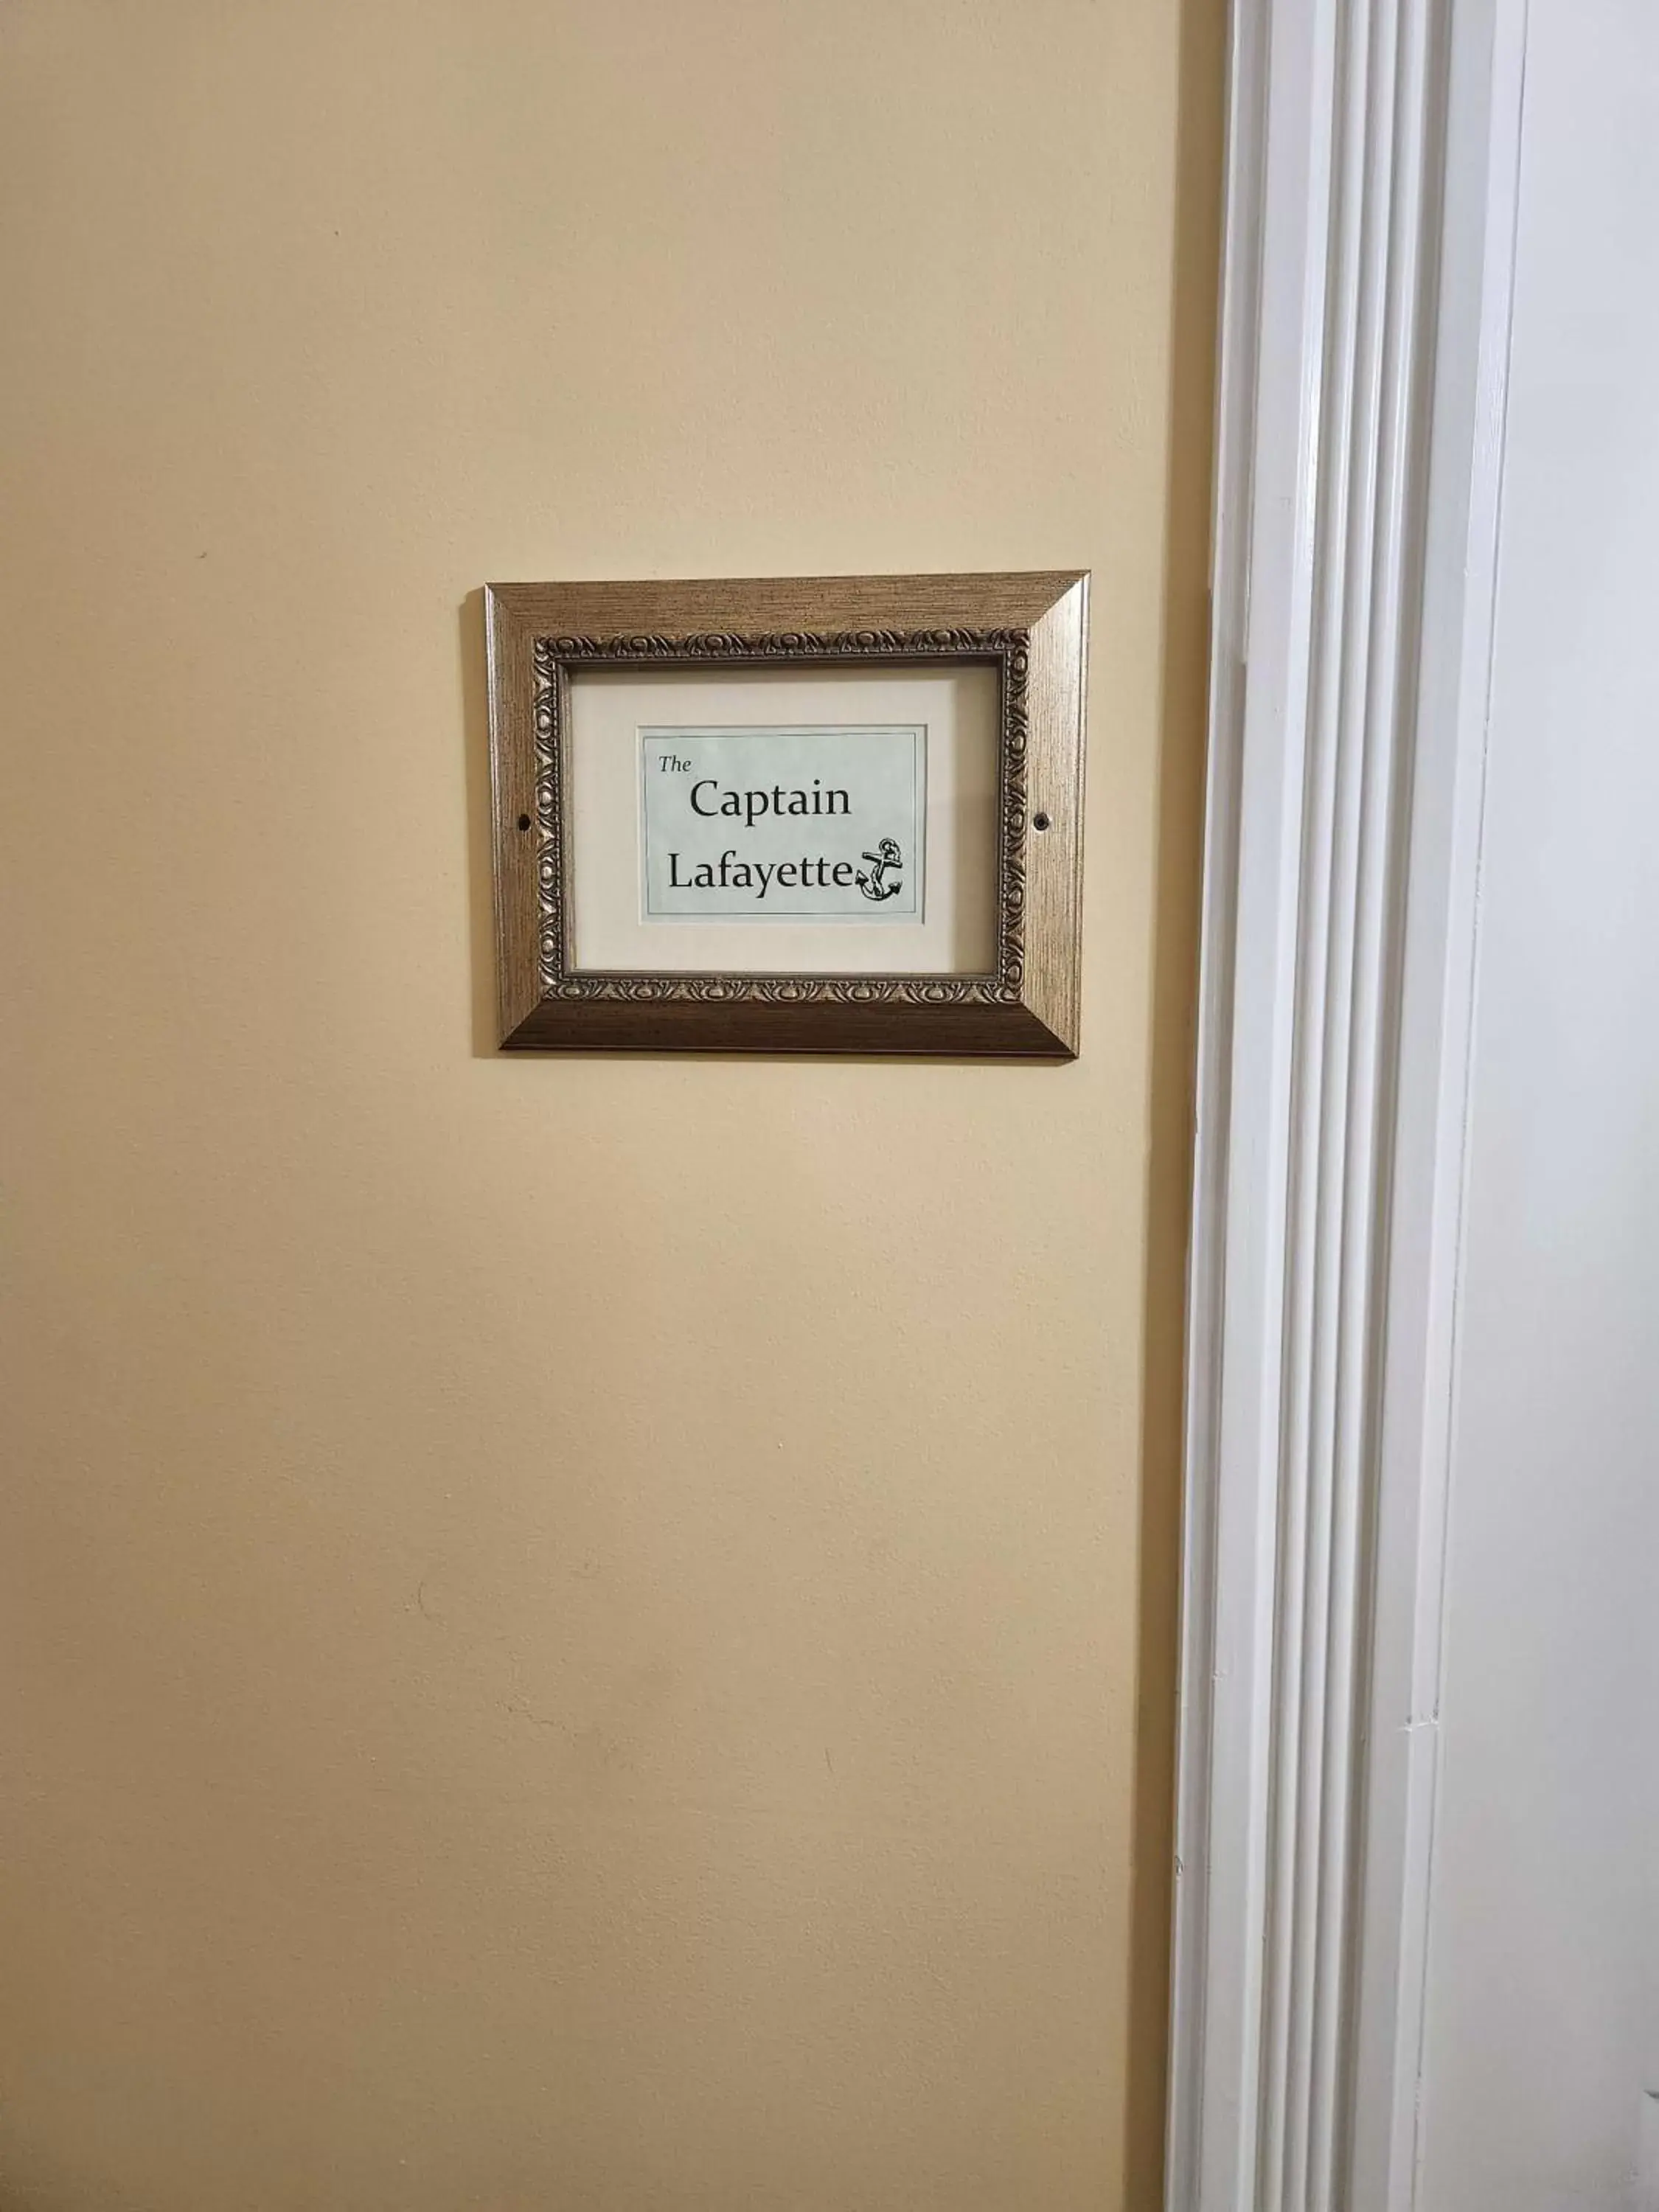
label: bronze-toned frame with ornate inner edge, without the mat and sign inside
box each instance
[484,568,1088,1060]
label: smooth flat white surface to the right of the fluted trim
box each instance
[1420,0,1659,2212]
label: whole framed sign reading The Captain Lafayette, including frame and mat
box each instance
[484,571,1088,1060]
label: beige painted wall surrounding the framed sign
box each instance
[0,0,1221,2212]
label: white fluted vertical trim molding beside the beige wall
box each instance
[1166,0,1526,2212]
